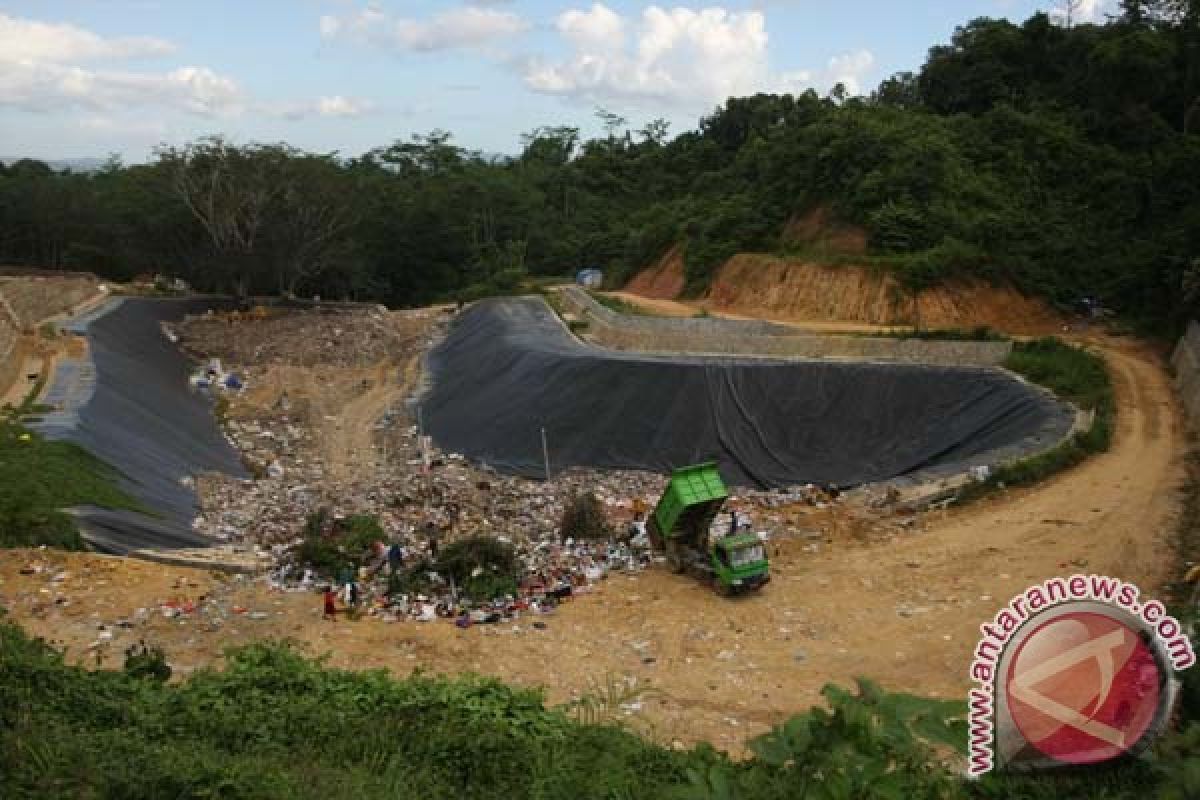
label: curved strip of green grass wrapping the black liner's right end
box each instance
[958,337,1116,503]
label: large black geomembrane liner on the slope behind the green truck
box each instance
[421,297,1073,488]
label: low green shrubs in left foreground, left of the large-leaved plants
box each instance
[0,625,700,800]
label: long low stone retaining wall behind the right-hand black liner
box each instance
[559,287,1013,367]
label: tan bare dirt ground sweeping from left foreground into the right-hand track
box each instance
[0,339,1183,751]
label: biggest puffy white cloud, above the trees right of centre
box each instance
[524,2,875,109]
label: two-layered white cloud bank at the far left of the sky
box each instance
[0,16,244,115]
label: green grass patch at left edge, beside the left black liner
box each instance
[0,417,145,549]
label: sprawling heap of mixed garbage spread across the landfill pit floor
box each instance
[182,299,864,625]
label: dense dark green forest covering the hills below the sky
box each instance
[7,0,1200,331]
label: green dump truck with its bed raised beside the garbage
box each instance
[646,462,770,594]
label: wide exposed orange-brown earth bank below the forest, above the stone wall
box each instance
[706,254,1063,333]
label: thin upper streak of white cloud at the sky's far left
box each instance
[0,13,175,64]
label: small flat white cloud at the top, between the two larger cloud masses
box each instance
[319,6,529,52]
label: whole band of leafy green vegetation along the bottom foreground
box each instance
[0,622,1200,800]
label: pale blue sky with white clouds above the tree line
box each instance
[0,0,1115,162]
